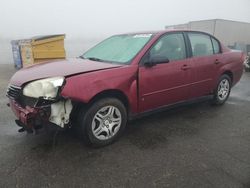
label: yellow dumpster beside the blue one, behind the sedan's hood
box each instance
[19,35,65,67]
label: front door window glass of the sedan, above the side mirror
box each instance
[149,33,186,61]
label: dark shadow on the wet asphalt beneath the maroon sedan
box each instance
[26,102,219,152]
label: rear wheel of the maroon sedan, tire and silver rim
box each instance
[212,74,232,105]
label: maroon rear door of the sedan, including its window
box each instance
[187,32,220,98]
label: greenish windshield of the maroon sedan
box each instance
[81,34,152,64]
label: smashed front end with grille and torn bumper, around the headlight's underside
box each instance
[7,85,73,132]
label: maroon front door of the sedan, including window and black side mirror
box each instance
[138,32,192,111]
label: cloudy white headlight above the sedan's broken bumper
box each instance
[23,77,64,99]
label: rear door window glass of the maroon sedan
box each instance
[188,33,214,57]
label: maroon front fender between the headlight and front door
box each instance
[61,66,138,113]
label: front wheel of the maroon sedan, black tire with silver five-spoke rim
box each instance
[78,98,127,147]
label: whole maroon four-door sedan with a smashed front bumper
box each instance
[7,30,245,146]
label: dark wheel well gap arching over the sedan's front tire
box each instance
[88,89,130,112]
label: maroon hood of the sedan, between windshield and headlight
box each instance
[10,58,122,86]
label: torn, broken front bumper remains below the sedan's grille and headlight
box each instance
[8,99,73,133]
